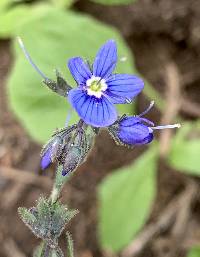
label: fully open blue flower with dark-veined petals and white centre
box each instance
[68,40,144,127]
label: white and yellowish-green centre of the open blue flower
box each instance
[86,76,108,98]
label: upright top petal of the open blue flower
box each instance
[93,40,117,78]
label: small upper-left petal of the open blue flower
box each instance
[68,57,92,85]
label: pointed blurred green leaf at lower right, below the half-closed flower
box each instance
[99,147,157,252]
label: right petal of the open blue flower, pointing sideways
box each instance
[106,74,144,104]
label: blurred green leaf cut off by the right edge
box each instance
[168,123,200,176]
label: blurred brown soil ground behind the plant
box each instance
[0,0,200,257]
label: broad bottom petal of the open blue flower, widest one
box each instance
[68,89,117,127]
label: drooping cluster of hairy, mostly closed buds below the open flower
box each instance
[41,121,95,176]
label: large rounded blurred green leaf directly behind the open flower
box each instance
[8,6,138,143]
